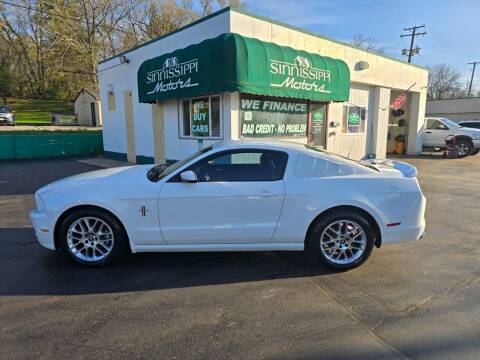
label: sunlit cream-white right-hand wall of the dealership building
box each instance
[231,11,428,158]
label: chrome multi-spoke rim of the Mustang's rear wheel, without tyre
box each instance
[320,220,367,265]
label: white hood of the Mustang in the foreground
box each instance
[37,165,152,196]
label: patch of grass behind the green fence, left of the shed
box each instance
[7,99,73,125]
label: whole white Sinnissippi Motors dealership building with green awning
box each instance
[98,8,428,163]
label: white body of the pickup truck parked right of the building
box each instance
[423,117,480,149]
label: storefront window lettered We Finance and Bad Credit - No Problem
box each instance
[240,94,308,138]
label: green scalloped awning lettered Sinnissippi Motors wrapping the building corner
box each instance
[137,33,350,103]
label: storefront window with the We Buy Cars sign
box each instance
[180,96,221,138]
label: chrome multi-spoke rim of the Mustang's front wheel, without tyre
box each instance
[67,217,114,262]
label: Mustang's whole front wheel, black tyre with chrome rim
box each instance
[58,208,127,266]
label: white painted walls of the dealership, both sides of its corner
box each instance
[99,10,428,160]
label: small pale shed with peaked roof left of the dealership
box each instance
[73,88,102,126]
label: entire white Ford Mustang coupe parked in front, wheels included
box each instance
[30,141,426,269]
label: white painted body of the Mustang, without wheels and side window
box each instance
[30,141,426,253]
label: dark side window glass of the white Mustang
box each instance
[189,150,288,182]
